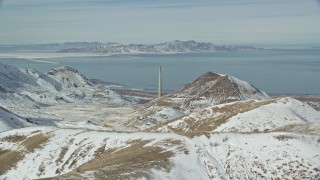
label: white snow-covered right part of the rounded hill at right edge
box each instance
[215,98,320,132]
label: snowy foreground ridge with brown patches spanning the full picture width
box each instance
[0,127,320,180]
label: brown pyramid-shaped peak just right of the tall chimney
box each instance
[169,72,269,104]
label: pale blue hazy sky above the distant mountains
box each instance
[0,0,320,44]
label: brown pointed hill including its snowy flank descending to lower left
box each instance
[129,72,270,129]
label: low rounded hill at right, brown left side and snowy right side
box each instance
[149,98,320,133]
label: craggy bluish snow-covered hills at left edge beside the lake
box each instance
[0,63,124,107]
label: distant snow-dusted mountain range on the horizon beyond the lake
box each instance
[0,40,261,54]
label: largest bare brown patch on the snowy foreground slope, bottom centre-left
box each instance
[58,140,178,179]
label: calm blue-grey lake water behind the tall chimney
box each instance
[0,49,320,95]
